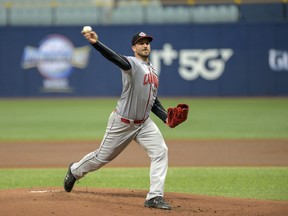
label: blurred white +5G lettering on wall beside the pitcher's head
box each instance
[151,44,233,81]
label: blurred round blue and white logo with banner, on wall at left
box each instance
[22,34,90,92]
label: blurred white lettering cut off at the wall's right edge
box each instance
[268,49,288,71]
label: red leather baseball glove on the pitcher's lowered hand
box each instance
[167,104,189,128]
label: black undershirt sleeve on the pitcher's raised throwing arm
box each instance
[92,41,131,71]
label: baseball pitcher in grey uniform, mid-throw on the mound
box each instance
[64,28,189,210]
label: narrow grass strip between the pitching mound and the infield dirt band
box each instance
[0,167,288,200]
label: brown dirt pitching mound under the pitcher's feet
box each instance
[0,188,288,216]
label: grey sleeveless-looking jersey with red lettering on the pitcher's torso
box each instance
[116,57,159,120]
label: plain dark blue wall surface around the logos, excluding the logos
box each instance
[0,23,288,97]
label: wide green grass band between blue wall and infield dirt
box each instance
[0,98,288,141]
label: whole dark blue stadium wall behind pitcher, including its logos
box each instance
[0,23,288,97]
